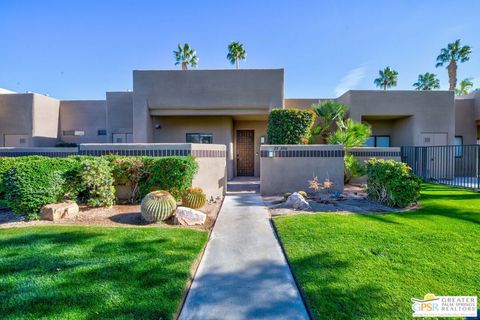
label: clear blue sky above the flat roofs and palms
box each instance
[0,0,480,99]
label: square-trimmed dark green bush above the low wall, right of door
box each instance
[267,109,316,144]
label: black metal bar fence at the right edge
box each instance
[401,145,480,190]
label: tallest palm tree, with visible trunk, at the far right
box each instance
[435,39,472,91]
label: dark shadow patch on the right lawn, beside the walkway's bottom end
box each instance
[291,252,390,319]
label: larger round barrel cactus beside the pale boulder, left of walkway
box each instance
[140,190,177,222]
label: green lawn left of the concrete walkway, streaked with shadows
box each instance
[0,227,207,319]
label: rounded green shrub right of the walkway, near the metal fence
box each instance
[366,158,421,208]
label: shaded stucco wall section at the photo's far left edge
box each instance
[0,93,33,147]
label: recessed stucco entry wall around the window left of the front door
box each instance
[153,116,234,179]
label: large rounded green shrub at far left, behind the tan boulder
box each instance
[3,159,65,219]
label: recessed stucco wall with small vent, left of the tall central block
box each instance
[59,100,108,143]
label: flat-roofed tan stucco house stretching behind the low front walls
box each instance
[0,69,480,178]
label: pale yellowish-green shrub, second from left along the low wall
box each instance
[78,158,115,207]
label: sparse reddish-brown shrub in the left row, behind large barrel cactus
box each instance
[106,156,146,203]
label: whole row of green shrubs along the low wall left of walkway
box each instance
[0,156,198,219]
